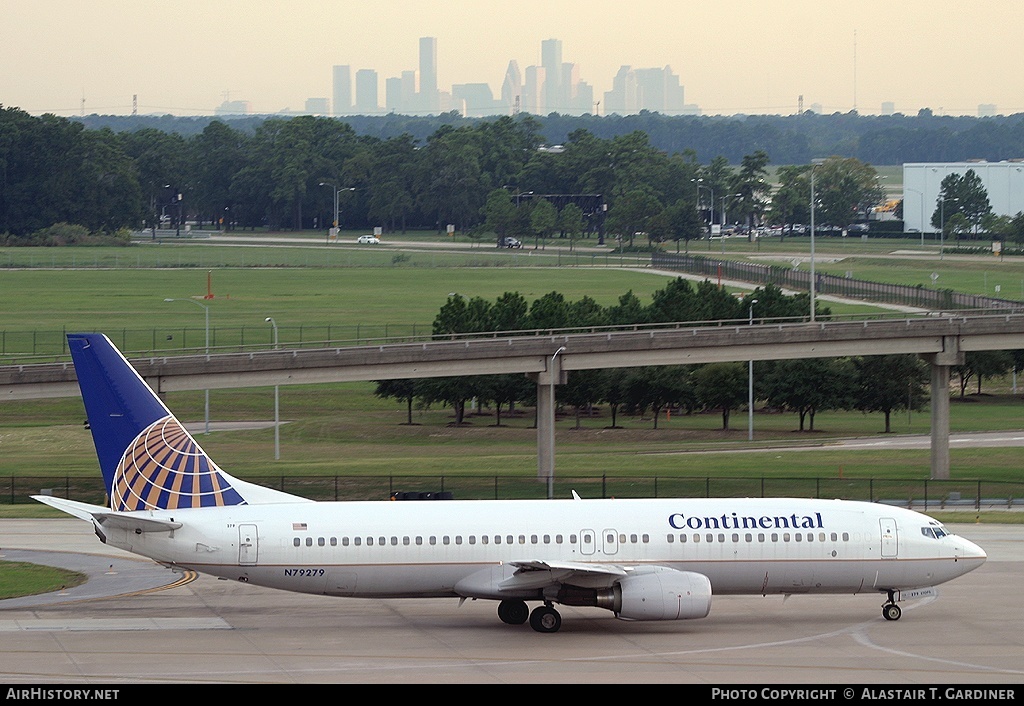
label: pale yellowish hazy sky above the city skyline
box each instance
[0,0,1024,115]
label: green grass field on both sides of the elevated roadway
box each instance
[0,234,1024,514]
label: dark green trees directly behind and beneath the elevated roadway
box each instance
[376,278,1024,431]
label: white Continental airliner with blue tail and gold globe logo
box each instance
[36,334,986,632]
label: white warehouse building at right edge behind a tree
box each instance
[903,160,1024,233]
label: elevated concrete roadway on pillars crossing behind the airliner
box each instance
[0,313,1024,477]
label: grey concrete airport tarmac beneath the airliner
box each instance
[0,520,1024,684]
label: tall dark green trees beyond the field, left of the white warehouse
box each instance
[0,103,897,246]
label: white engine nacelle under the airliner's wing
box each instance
[613,567,711,620]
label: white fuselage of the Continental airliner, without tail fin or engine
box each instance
[97,499,985,598]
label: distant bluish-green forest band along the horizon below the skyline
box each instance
[74,109,1024,165]
